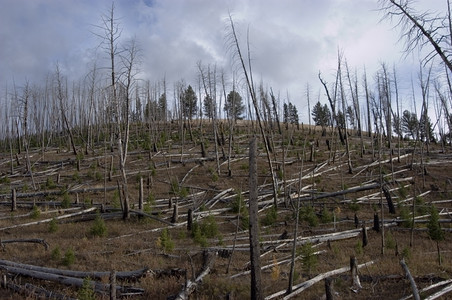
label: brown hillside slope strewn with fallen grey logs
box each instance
[0,121,452,299]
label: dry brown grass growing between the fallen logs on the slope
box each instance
[0,122,452,299]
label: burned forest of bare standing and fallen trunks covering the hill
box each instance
[0,0,452,300]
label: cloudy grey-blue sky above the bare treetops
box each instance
[0,0,445,120]
